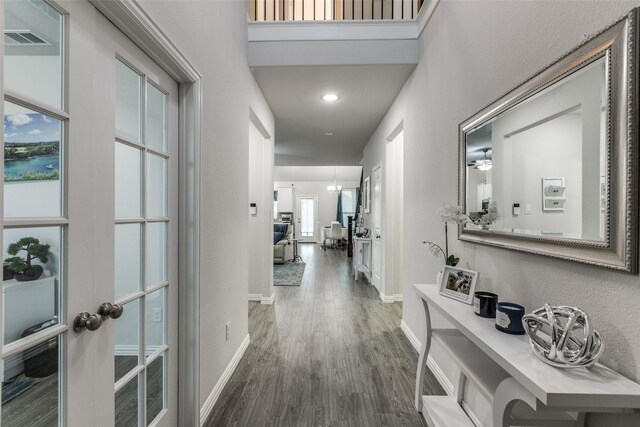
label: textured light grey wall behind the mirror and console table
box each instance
[364,0,640,426]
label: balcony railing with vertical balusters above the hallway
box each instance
[251,0,424,22]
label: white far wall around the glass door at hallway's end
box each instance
[275,180,360,241]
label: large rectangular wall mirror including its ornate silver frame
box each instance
[459,9,638,274]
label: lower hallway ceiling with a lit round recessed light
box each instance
[252,64,415,167]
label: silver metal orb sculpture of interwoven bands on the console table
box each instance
[522,304,604,368]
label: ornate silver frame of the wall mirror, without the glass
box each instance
[458,8,638,274]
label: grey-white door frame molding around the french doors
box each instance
[89,0,202,426]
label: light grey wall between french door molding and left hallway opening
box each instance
[141,0,274,414]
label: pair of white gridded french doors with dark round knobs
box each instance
[0,0,178,427]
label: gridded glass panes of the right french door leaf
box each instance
[114,59,171,427]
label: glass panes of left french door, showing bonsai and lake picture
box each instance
[1,0,69,427]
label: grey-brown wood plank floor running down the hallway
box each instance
[205,244,444,427]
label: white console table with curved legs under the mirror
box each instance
[413,285,640,427]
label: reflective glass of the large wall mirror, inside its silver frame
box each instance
[465,56,608,242]
